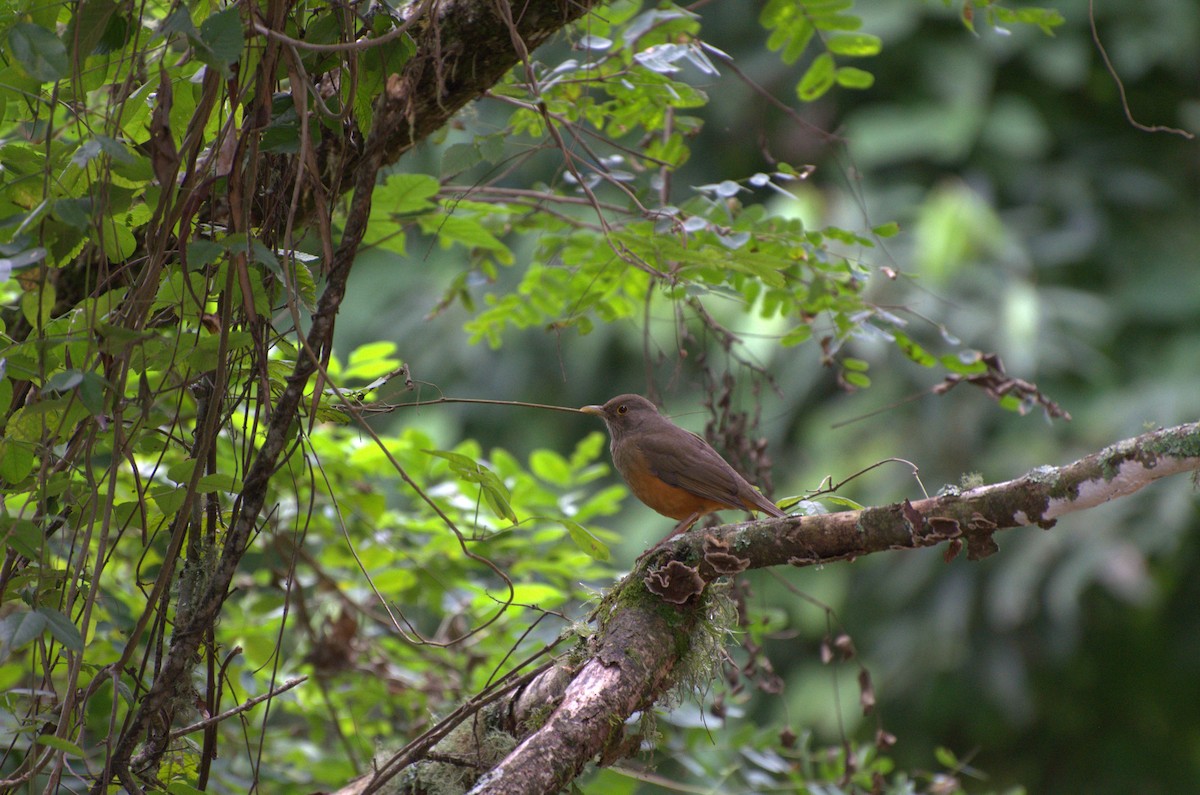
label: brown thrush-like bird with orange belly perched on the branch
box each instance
[580,395,787,544]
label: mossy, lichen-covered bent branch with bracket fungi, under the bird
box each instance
[381,423,1200,795]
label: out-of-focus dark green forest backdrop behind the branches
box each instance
[338,0,1200,793]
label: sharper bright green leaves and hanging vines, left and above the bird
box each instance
[0,0,1166,791]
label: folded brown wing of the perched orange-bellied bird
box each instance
[637,425,786,516]
